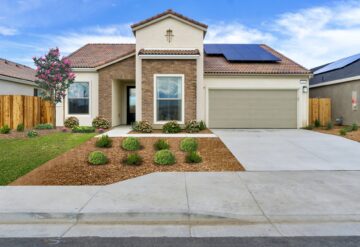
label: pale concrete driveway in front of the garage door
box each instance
[212,129,360,171]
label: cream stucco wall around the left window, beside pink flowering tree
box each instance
[56,72,99,126]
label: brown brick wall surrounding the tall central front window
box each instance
[141,59,196,123]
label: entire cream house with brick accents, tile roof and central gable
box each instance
[57,10,310,128]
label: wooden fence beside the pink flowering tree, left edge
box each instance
[0,95,55,129]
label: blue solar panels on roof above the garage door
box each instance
[204,44,281,62]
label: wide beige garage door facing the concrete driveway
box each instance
[209,89,297,128]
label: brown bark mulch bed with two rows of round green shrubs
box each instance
[11,137,244,185]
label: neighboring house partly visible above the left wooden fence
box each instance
[0,58,38,96]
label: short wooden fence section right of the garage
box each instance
[309,98,331,126]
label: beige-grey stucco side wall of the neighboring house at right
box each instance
[310,80,360,124]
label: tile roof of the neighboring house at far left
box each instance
[0,58,35,82]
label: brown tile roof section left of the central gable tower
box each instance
[68,44,135,68]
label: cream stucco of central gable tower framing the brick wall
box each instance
[136,18,205,120]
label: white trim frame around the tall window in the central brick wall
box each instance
[153,74,185,124]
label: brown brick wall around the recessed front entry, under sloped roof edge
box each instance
[99,56,135,122]
